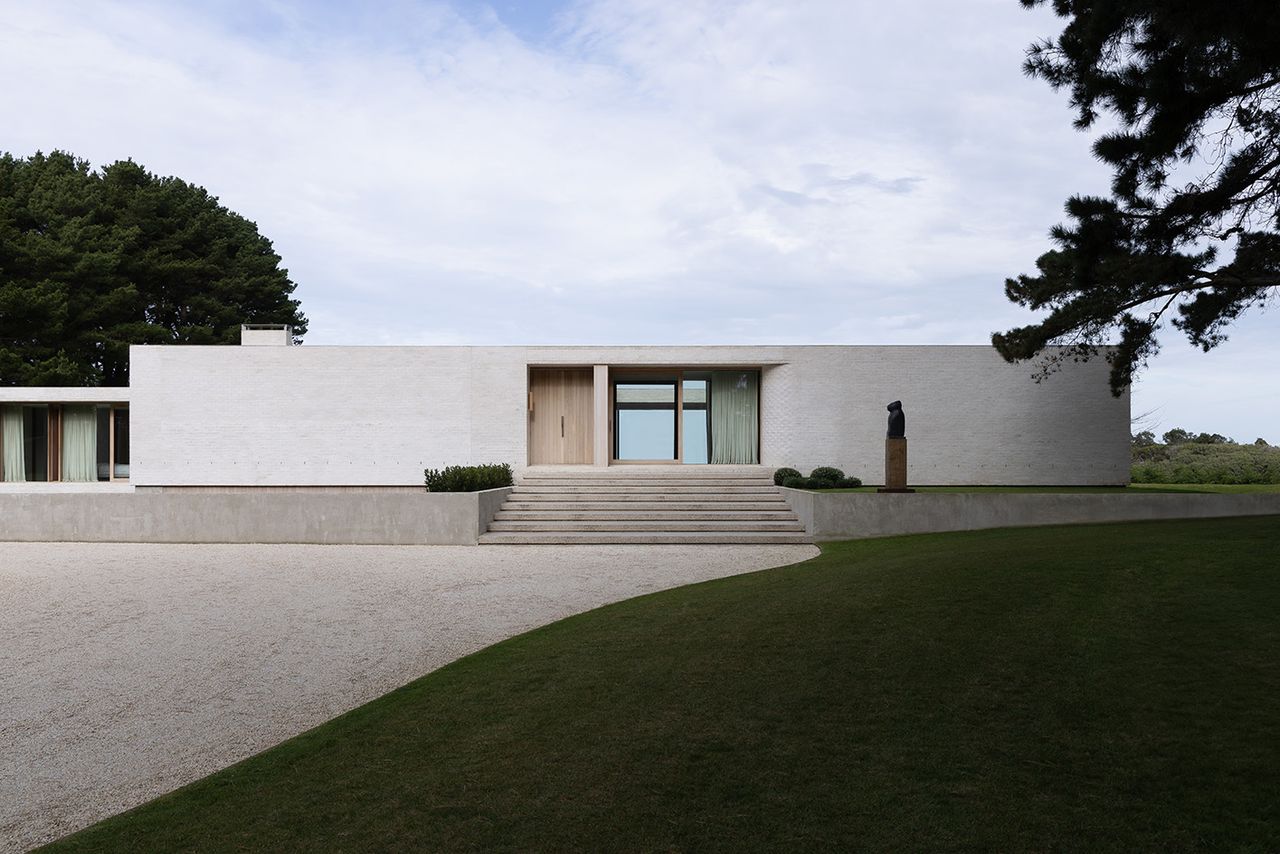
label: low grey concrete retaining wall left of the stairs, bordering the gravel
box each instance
[0,488,511,545]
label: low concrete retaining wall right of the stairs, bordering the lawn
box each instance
[782,489,1280,540]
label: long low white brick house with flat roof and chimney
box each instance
[0,330,1129,489]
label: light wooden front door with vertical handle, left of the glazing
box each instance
[529,367,595,466]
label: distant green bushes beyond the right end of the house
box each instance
[1130,442,1280,484]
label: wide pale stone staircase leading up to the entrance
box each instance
[480,466,813,545]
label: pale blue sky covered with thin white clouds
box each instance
[0,0,1280,443]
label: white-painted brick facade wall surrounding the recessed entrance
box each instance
[129,346,1129,485]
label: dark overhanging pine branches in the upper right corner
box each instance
[992,0,1280,394]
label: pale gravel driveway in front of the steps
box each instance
[0,543,818,851]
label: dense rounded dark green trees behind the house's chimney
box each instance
[0,151,307,385]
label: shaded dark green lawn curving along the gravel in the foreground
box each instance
[45,517,1280,851]
